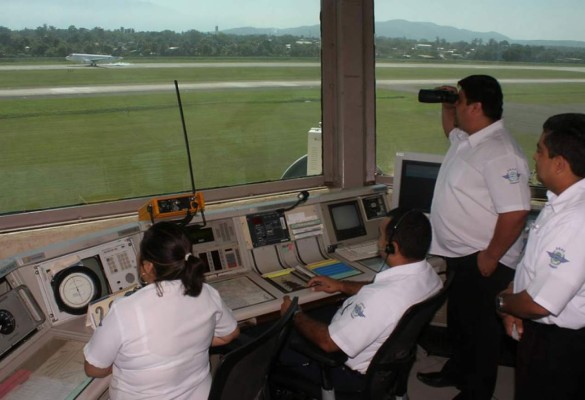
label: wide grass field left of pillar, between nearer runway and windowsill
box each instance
[0,90,320,211]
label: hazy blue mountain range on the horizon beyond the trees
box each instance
[221,19,585,47]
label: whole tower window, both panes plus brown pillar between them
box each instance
[10,0,585,231]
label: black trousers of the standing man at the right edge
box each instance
[515,320,585,400]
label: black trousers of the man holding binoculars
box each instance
[443,253,514,400]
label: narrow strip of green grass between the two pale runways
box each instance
[0,60,585,89]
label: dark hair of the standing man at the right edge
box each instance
[542,113,585,178]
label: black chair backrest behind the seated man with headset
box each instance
[364,274,453,399]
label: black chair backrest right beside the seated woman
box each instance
[209,297,298,400]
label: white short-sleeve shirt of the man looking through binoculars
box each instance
[431,120,530,268]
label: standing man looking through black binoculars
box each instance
[418,75,530,400]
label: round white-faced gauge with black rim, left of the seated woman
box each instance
[51,266,101,315]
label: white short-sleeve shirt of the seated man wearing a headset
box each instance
[329,261,443,373]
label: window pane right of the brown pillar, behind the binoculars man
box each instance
[375,0,585,175]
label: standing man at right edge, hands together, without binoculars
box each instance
[496,114,585,400]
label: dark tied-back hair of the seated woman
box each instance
[140,221,205,297]
